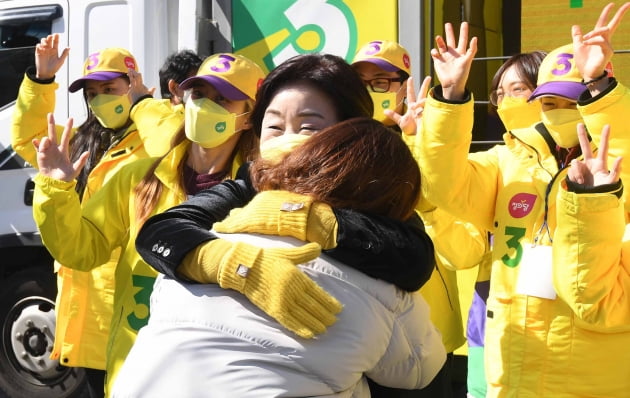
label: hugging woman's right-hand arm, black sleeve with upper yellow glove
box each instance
[215,191,435,291]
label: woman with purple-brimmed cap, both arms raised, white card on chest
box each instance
[421,3,630,397]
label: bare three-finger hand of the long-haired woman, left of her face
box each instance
[33,113,88,181]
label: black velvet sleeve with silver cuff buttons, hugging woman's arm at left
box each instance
[136,173,256,279]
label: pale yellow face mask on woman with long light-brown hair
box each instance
[184,98,247,148]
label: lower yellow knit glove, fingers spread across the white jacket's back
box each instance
[177,239,342,339]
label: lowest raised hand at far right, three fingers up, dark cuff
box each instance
[568,123,622,187]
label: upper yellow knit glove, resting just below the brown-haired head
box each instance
[214,191,337,249]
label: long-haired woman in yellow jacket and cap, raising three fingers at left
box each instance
[33,53,264,398]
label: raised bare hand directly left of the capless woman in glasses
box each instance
[431,22,477,100]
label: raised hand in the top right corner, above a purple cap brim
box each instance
[571,2,630,81]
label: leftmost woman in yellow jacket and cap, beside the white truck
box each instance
[11,34,182,396]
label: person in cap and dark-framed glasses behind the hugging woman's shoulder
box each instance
[352,40,488,398]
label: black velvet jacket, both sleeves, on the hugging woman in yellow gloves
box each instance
[136,161,435,291]
